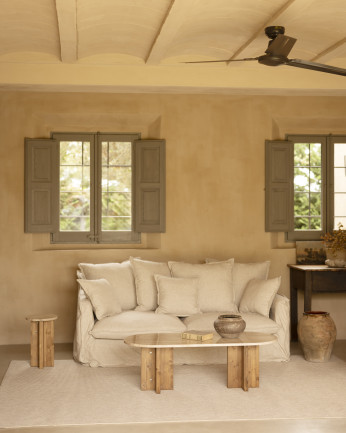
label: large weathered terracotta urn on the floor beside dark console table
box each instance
[298,311,336,362]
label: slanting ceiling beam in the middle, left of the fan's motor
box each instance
[145,0,198,65]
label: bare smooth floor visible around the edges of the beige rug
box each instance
[0,340,346,433]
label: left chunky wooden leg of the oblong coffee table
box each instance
[141,348,173,394]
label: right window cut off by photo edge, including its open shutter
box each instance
[266,135,346,241]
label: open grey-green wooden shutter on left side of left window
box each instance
[24,138,59,233]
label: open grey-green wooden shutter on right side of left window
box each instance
[134,140,166,233]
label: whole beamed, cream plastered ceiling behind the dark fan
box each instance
[0,0,346,95]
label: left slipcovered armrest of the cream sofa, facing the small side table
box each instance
[73,288,95,362]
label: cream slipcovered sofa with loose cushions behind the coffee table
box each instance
[73,258,290,367]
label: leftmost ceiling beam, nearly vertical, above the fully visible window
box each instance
[55,0,78,63]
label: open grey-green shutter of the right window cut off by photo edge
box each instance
[265,140,293,232]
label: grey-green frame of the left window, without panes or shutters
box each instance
[51,132,141,244]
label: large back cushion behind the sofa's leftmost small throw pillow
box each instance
[79,260,137,310]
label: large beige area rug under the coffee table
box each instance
[0,356,346,428]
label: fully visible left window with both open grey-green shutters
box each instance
[25,133,165,243]
